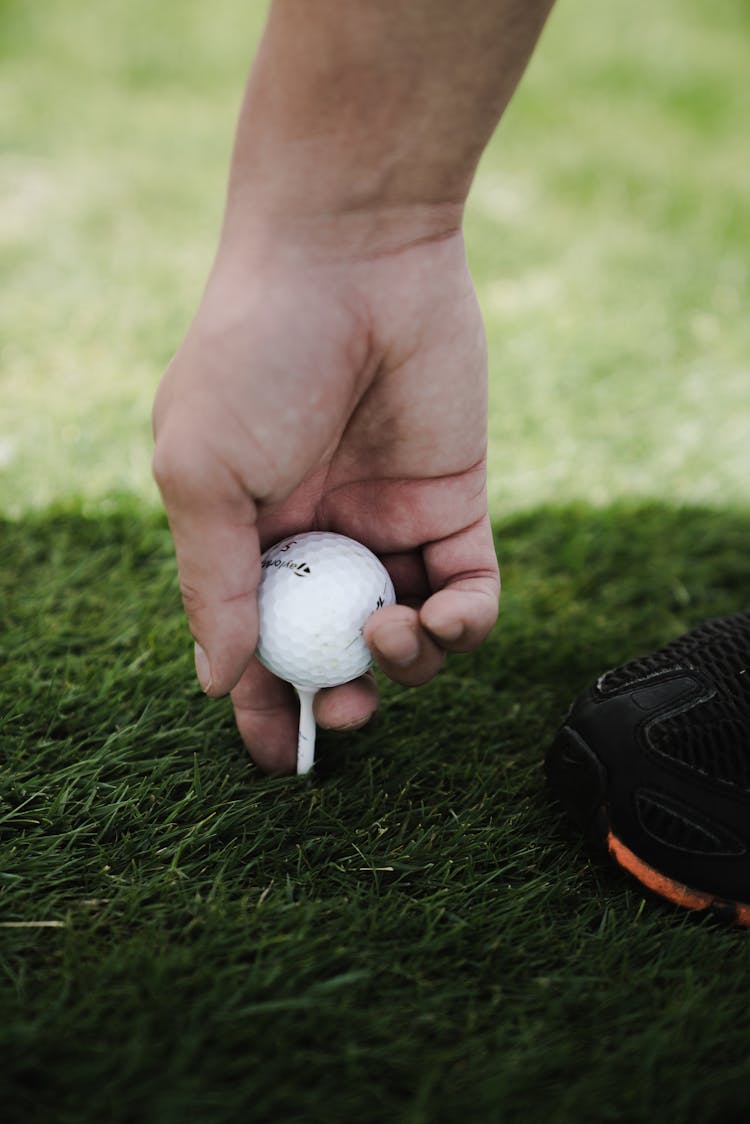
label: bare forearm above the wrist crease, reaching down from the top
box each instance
[224,0,552,258]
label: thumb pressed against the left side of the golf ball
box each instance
[153,432,261,697]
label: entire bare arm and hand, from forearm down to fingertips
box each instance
[154,0,557,772]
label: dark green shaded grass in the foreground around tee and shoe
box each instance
[0,500,750,1124]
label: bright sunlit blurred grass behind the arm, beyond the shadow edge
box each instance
[0,0,750,516]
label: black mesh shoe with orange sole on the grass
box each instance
[545,611,750,926]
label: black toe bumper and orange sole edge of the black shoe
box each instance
[545,726,750,928]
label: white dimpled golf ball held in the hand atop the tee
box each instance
[257,531,396,690]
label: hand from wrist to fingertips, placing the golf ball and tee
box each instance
[154,232,499,772]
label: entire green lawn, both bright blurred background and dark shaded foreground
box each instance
[0,0,750,1124]
